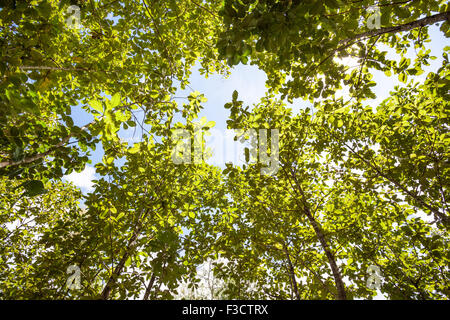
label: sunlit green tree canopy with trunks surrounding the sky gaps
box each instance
[0,0,450,300]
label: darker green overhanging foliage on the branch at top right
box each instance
[217,0,449,100]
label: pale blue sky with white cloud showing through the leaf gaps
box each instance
[65,26,449,193]
